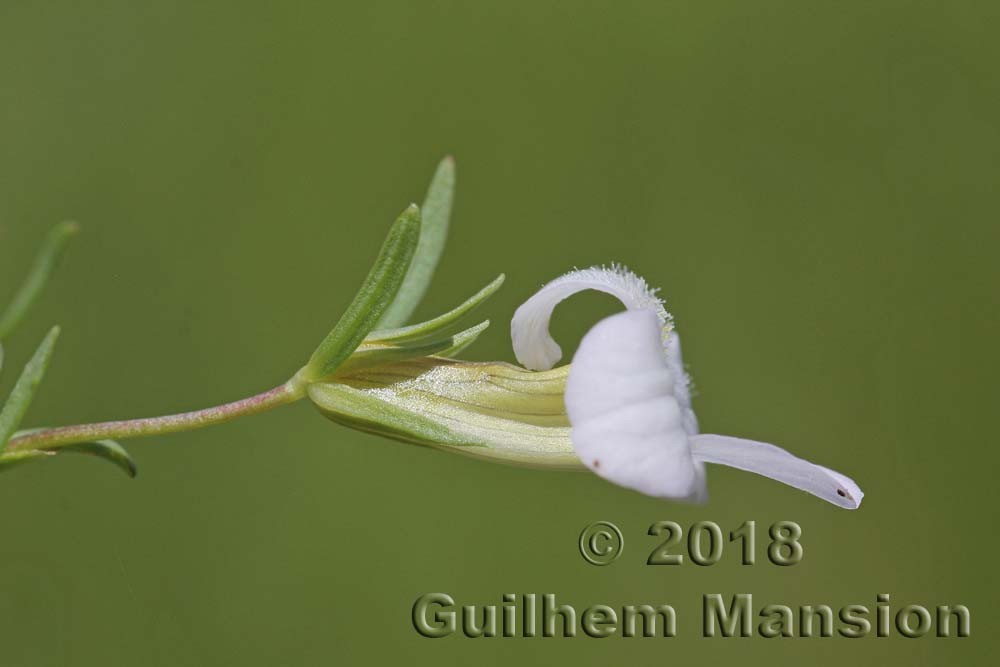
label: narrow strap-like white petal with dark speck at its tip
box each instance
[691,434,865,510]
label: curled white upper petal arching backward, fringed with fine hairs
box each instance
[510,264,674,370]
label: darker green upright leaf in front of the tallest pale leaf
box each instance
[305,204,420,381]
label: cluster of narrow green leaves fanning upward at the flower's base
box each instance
[303,158,503,382]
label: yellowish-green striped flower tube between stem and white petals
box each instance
[308,357,581,469]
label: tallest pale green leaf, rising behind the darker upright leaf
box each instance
[379,156,455,328]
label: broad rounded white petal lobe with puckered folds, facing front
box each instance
[565,310,706,501]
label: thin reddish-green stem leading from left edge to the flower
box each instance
[7,375,306,452]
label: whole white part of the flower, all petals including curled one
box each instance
[511,267,864,509]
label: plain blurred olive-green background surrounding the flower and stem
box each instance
[0,0,1000,666]
